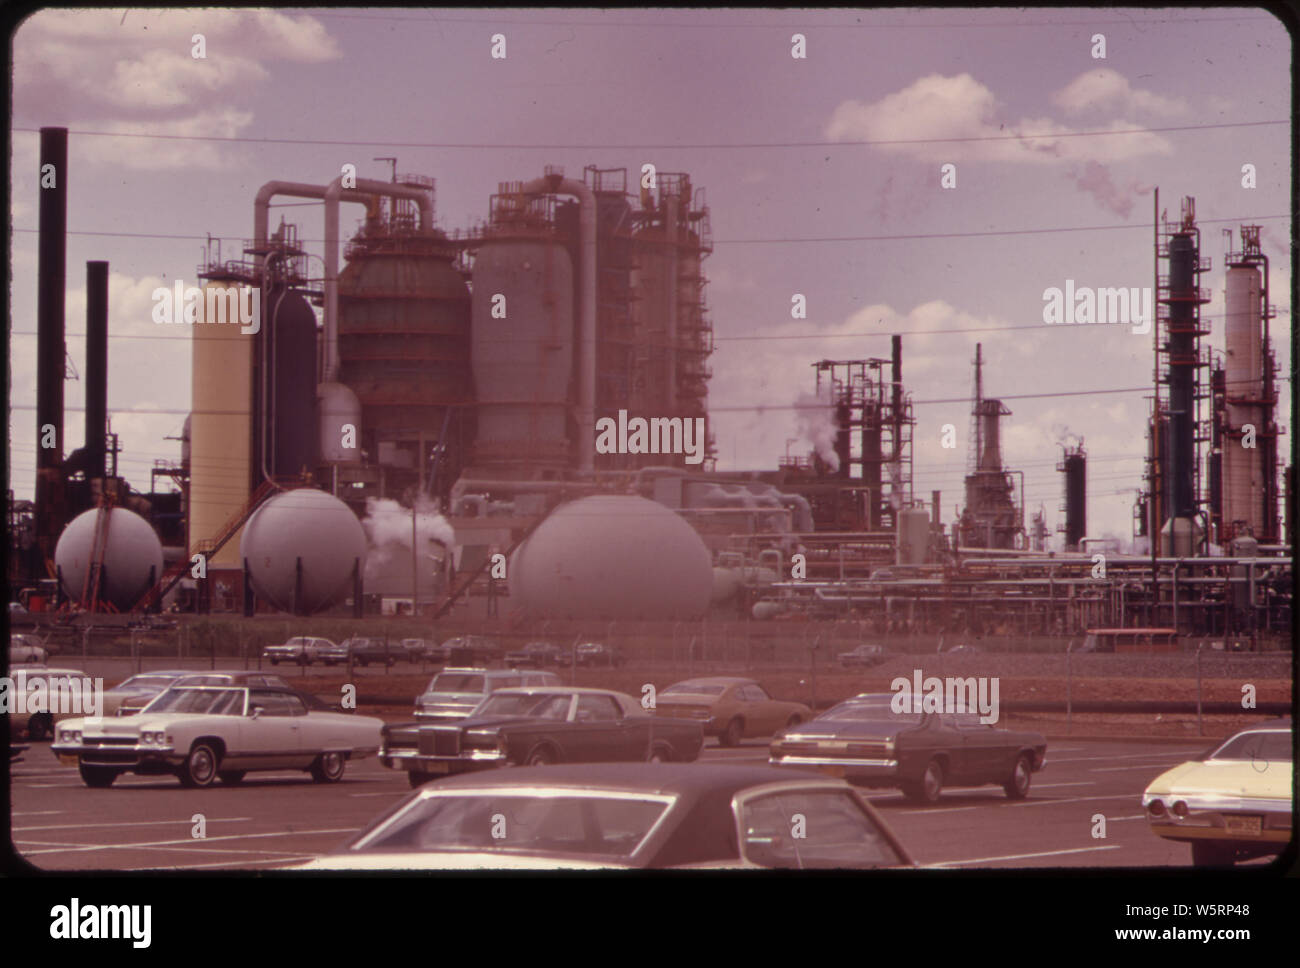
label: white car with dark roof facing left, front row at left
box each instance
[51,686,384,786]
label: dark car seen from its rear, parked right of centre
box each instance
[768,693,1048,803]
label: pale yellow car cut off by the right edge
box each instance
[1141,719,1294,867]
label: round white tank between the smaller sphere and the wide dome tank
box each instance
[239,487,365,615]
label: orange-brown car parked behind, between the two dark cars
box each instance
[655,676,813,746]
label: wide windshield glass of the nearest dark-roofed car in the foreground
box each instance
[352,791,670,858]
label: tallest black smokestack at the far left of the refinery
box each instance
[36,127,68,559]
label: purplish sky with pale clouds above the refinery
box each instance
[9,8,1292,548]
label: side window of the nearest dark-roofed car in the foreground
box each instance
[741,790,902,871]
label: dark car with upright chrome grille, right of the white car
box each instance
[380,686,705,786]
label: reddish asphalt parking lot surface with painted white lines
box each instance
[10,739,1237,871]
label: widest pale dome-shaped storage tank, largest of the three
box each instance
[510,496,714,620]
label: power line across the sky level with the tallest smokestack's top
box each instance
[10,120,1291,151]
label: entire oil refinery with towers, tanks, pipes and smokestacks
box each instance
[8,127,1294,637]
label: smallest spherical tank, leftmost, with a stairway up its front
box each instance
[55,508,163,612]
